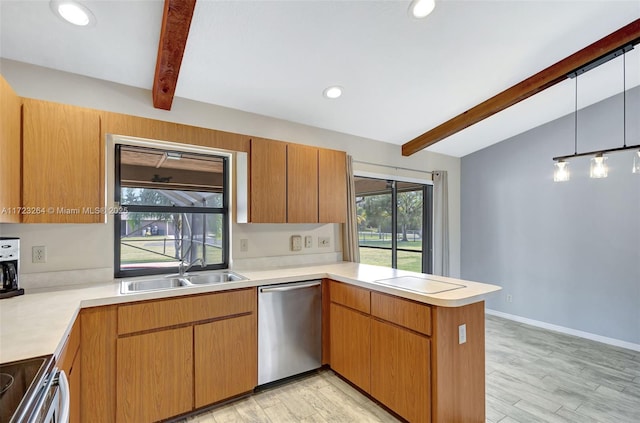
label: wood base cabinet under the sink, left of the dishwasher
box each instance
[80,288,258,423]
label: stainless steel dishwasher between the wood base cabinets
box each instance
[258,280,322,385]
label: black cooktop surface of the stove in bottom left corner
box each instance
[0,355,53,423]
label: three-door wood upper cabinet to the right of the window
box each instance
[250,138,347,223]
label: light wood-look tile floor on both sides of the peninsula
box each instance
[186,316,640,423]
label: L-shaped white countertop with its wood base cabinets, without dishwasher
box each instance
[0,262,500,422]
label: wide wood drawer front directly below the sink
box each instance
[118,288,256,335]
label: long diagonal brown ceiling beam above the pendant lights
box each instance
[402,19,640,156]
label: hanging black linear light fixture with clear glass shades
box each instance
[553,44,640,182]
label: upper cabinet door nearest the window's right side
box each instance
[250,138,287,223]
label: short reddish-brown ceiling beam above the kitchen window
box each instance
[152,0,196,110]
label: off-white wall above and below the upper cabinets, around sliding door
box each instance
[0,59,460,276]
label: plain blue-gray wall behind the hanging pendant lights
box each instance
[461,88,640,344]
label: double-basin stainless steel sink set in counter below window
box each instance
[120,270,247,294]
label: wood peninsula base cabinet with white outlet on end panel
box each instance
[328,281,485,423]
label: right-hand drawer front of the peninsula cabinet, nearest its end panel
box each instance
[371,292,431,335]
